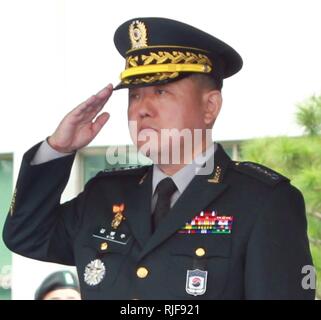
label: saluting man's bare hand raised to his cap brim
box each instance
[48,84,113,153]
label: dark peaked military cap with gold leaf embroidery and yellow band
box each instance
[114,18,243,89]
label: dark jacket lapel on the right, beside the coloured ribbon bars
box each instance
[139,145,231,259]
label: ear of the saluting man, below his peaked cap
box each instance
[203,90,223,127]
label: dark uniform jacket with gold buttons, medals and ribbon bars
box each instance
[3,145,314,300]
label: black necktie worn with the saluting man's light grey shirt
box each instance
[152,178,177,232]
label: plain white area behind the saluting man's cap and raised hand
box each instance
[0,0,321,153]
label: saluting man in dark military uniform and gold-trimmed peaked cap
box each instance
[3,18,314,300]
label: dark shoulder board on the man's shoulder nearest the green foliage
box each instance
[234,161,290,186]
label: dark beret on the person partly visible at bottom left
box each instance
[35,271,79,300]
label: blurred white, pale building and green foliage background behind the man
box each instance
[0,0,321,299]
